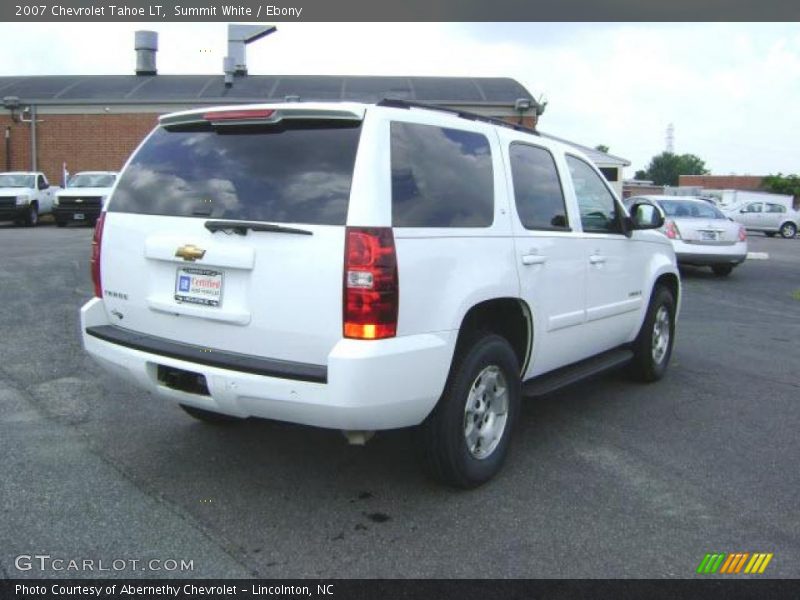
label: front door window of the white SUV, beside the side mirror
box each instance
[567,156,620,233]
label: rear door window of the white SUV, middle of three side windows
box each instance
[509,142,568,229]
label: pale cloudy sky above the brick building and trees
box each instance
[0,22,800,177]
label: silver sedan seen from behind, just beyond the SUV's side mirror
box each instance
[625,196,747,277]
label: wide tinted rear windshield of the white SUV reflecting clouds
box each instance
[109,121,361,225]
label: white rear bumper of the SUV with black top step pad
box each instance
[81,298,457,430]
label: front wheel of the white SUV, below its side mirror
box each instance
[630,285,675,382]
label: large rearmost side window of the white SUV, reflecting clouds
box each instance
[391,122,494,227]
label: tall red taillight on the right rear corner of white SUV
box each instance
[343,227,400,340]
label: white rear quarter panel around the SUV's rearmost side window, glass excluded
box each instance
[348,107,520,336]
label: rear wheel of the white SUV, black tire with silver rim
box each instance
[418,333,521,489]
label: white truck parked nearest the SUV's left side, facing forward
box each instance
[53,171,117,227]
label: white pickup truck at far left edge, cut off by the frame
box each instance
[0,171,61,227]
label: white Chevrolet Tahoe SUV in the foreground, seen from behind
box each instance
[81,100,680,487]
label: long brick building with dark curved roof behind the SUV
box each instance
[0,75,538,182]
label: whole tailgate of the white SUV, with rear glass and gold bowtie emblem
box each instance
[101,109,363,364]
